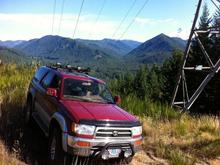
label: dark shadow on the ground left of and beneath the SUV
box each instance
[0,104,124,165]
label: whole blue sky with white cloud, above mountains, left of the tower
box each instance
[0,0,217,42]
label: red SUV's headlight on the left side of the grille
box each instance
[73,124,95,135]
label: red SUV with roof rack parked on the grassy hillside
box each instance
[26,65,142,164]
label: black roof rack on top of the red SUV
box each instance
[48,63,91,75]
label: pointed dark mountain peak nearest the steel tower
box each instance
[125,34,186,64]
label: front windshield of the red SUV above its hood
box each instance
[63,78,114,103]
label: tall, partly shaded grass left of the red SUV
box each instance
[0,64,35,157]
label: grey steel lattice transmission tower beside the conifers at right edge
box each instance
[172,0,220,110]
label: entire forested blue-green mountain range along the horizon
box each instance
[0,34,186,69]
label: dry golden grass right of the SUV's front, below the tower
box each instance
[142,114,220,164]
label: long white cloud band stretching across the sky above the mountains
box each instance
[0,13,189,42]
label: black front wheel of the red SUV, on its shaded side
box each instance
[48,128,72,165]
